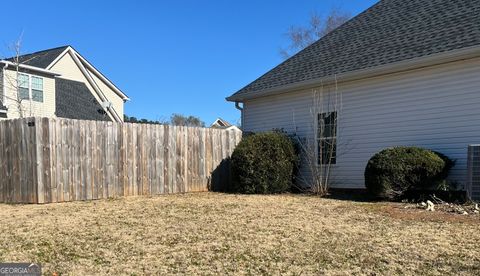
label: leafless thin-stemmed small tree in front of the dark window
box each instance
[294,77,346,196]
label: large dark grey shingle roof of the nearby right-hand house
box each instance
[231,0,480,97]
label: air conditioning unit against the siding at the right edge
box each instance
[467,145,480,201]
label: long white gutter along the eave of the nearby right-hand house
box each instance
[226,46,480,102]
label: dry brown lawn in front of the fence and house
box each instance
[0,193,480,275]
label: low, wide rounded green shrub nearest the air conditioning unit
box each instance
[365,147,454,199]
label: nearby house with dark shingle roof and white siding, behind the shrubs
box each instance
[227,0,480,191]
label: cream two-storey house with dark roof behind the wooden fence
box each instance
[0,46,129,122]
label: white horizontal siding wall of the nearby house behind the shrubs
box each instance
[243,58,480,188]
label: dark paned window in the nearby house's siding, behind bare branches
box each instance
[317,112,337,165]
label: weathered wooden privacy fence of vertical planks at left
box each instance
[0,118,241,203]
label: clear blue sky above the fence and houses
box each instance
[0,0,377,123]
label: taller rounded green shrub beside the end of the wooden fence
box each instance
[231,132,298,194]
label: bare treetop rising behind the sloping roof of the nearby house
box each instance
[280,9,351,59]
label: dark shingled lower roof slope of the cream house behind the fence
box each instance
[55,78,110,121]
